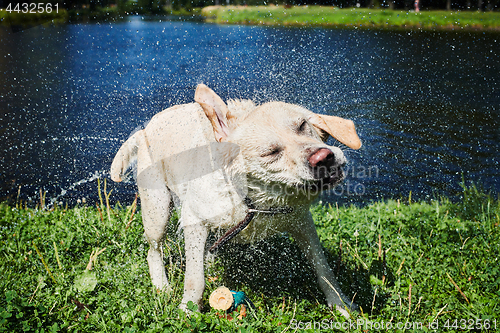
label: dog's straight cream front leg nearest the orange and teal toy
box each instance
[180,223,208,310]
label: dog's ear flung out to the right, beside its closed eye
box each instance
[309,112,361,149]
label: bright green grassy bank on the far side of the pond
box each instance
[202,6,500,30]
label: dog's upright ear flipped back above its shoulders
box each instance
[194,84,232,142]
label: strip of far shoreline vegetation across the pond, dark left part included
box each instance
[0,5,500,32]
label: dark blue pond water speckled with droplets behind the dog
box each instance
[0,17,500,204]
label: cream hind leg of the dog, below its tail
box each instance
[137,166,171,290]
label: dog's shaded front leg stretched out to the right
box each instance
[289,211,357,318]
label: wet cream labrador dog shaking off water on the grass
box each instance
[111,84,361,315]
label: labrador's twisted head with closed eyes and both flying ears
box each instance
[195,85,361,200]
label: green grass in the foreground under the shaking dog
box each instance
[0,180,500,332]
